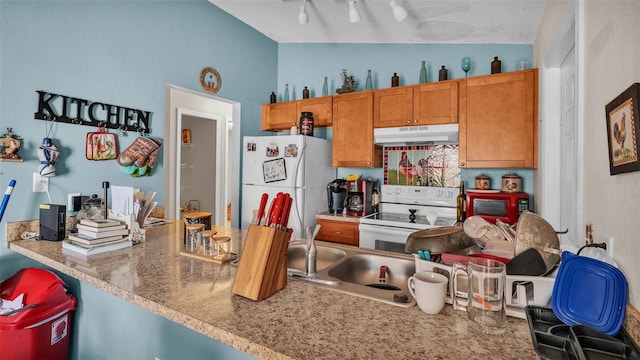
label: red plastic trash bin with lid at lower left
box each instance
[0,268,76,360]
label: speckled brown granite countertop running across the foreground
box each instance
[7,222,552,359]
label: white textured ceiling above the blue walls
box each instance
[209,0,545,44]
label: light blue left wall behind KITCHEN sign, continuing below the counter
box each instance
[0,0,277,359]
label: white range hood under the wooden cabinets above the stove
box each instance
[373,124,458,146]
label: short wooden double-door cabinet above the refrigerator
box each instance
[262,96,332,131]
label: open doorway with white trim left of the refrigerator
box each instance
[163,84,240,227]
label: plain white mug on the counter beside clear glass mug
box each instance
[407,271,449,314]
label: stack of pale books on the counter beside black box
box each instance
[62,219,132,255]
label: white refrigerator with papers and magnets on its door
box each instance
[241,135,336,238]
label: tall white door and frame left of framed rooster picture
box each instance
[536,4,584,252]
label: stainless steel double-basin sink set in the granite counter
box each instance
[287,240,416,307]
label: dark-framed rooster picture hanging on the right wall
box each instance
[605,83,640,175]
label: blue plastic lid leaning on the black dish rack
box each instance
[551,251,628,335]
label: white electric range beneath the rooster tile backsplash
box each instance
[358,185,459,253]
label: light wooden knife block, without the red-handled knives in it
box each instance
[231,225,289,301]
